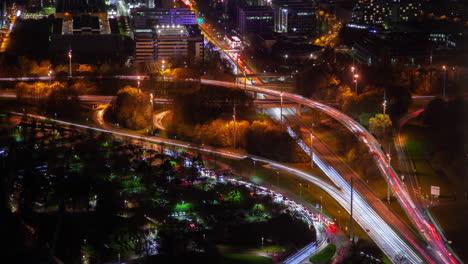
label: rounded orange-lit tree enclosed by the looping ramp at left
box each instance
[113,86,152,130]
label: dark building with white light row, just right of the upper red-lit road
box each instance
[237,6,275,34]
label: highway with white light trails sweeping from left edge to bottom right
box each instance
[9,109,426,263]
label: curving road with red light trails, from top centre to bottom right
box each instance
[178,0,461,263]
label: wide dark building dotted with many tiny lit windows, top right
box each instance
[351,0,421,24]
